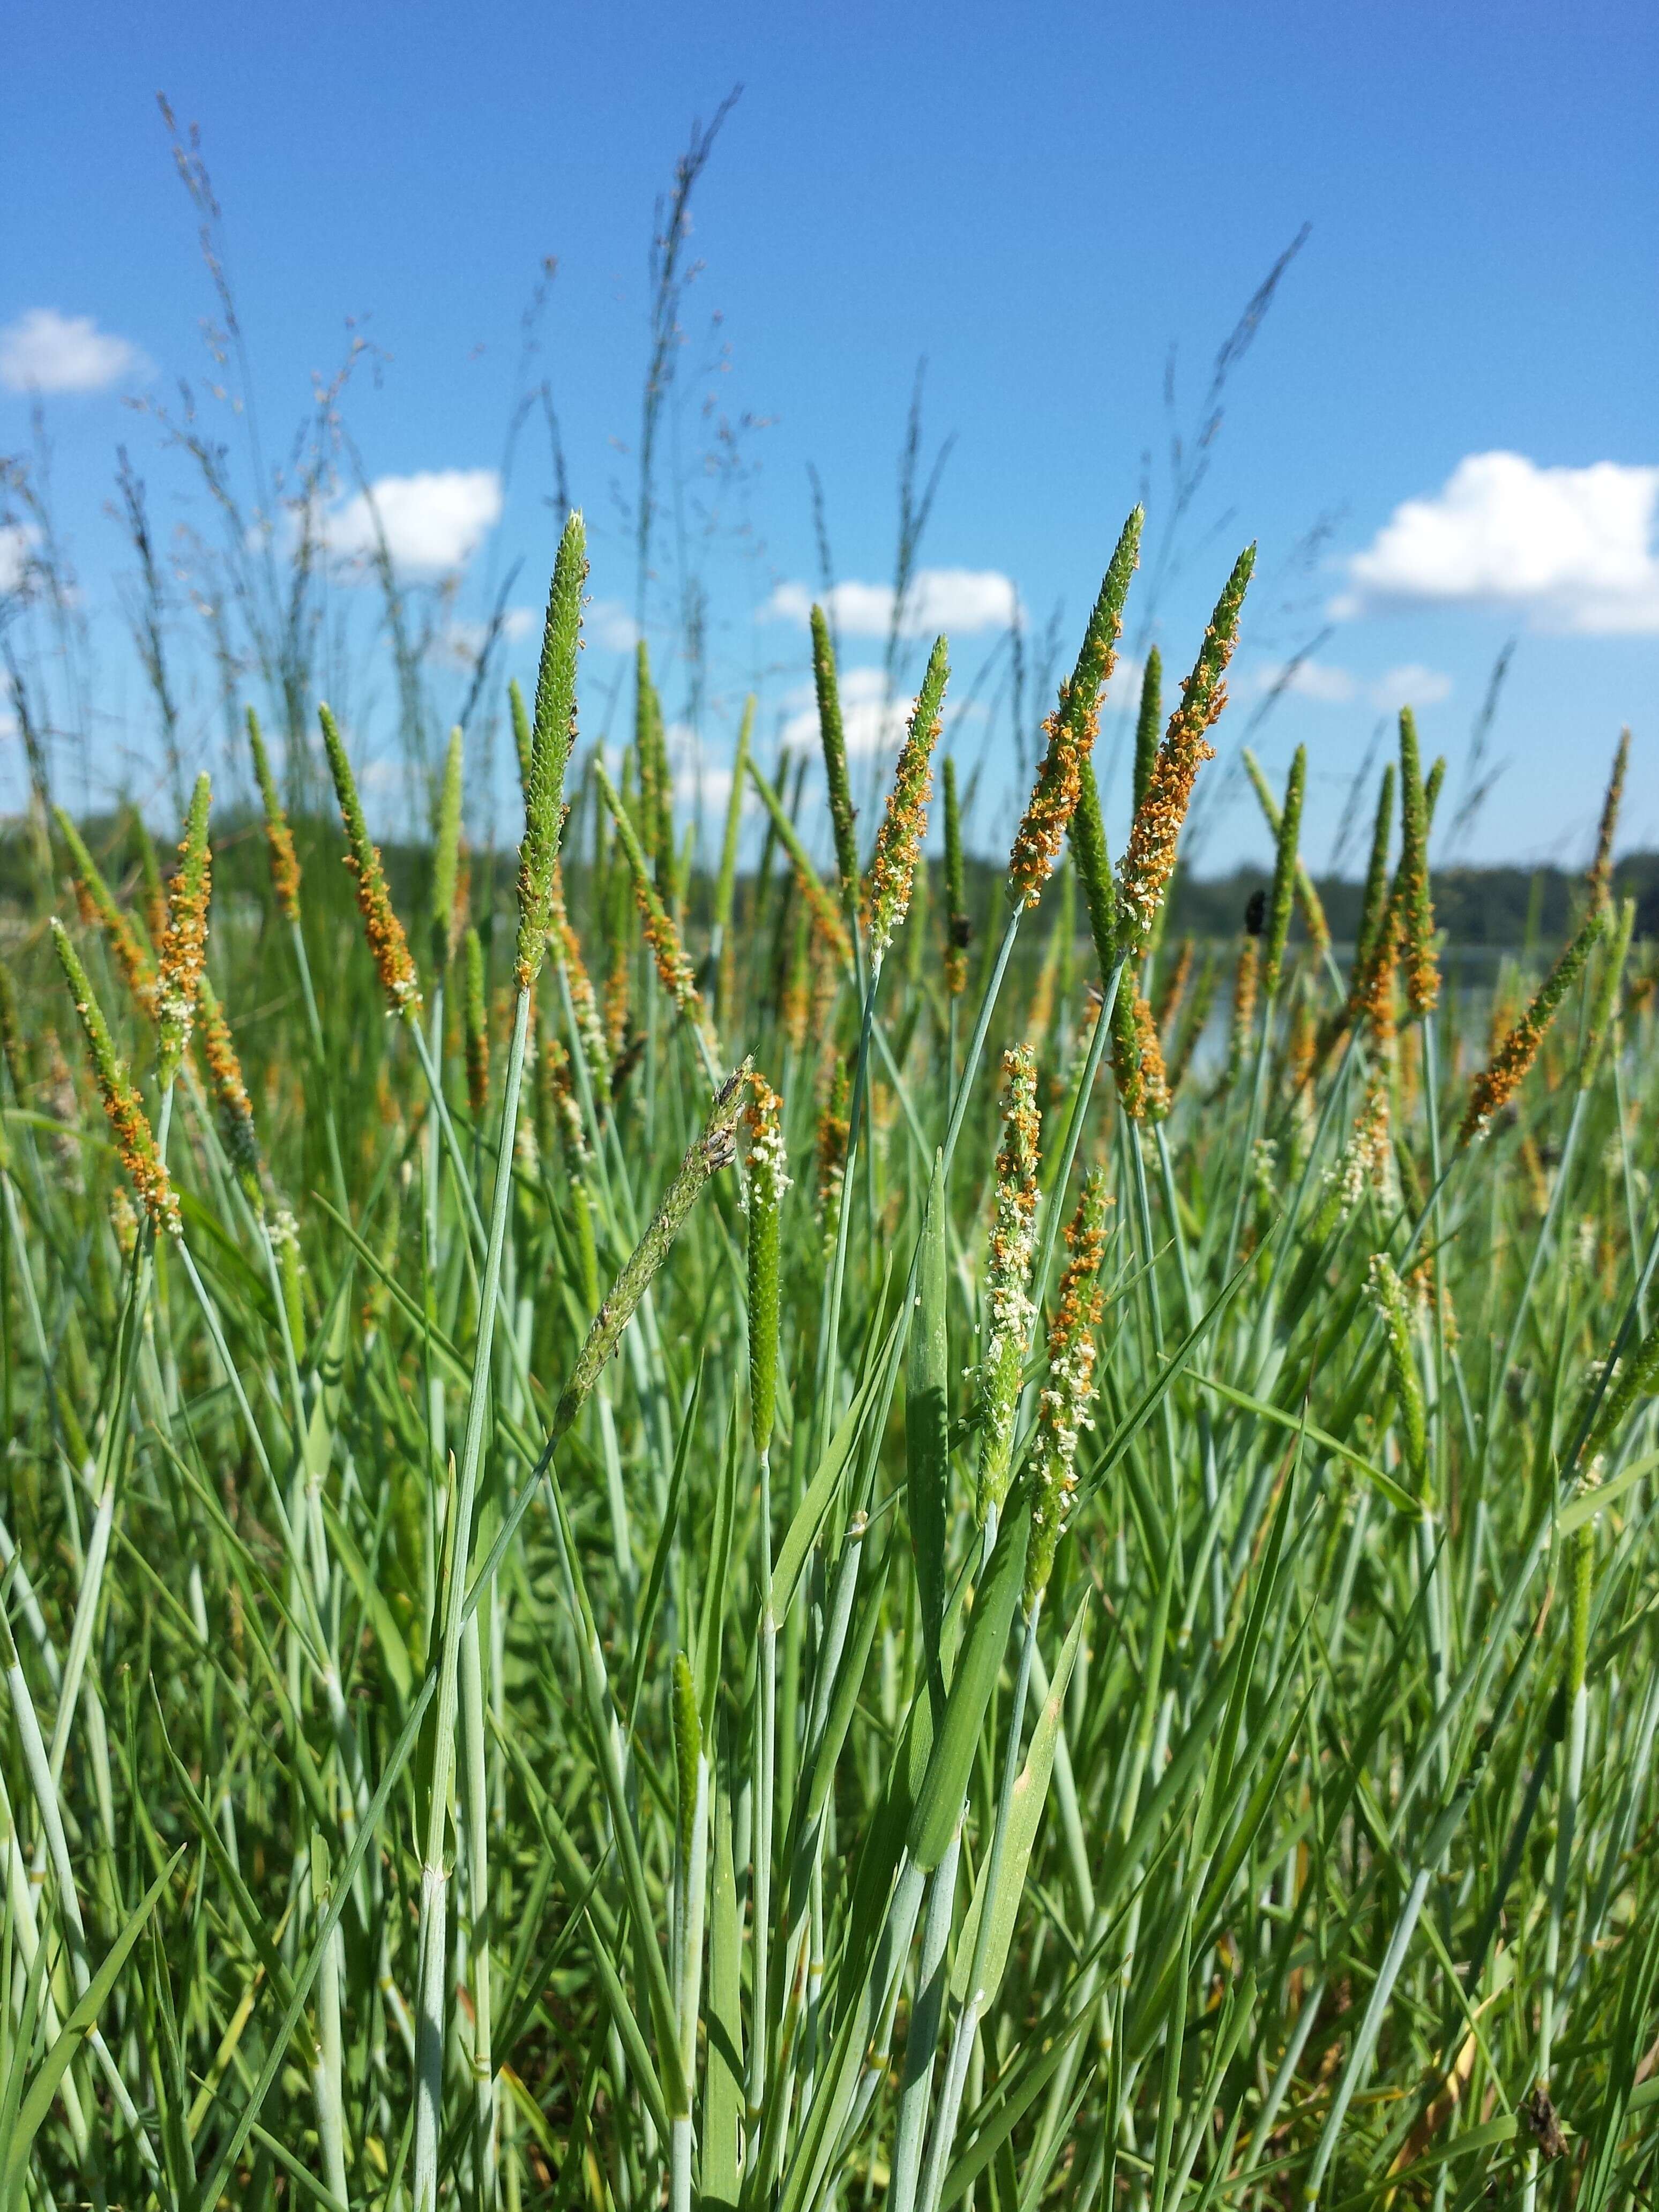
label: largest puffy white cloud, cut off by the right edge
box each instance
[1334,453,1659,637]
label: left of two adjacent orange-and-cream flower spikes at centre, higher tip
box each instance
[975,1044,1042,1526]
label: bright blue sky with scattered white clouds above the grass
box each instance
[0,0,1659,867]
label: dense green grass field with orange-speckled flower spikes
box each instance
[0,518,1659,2212]
